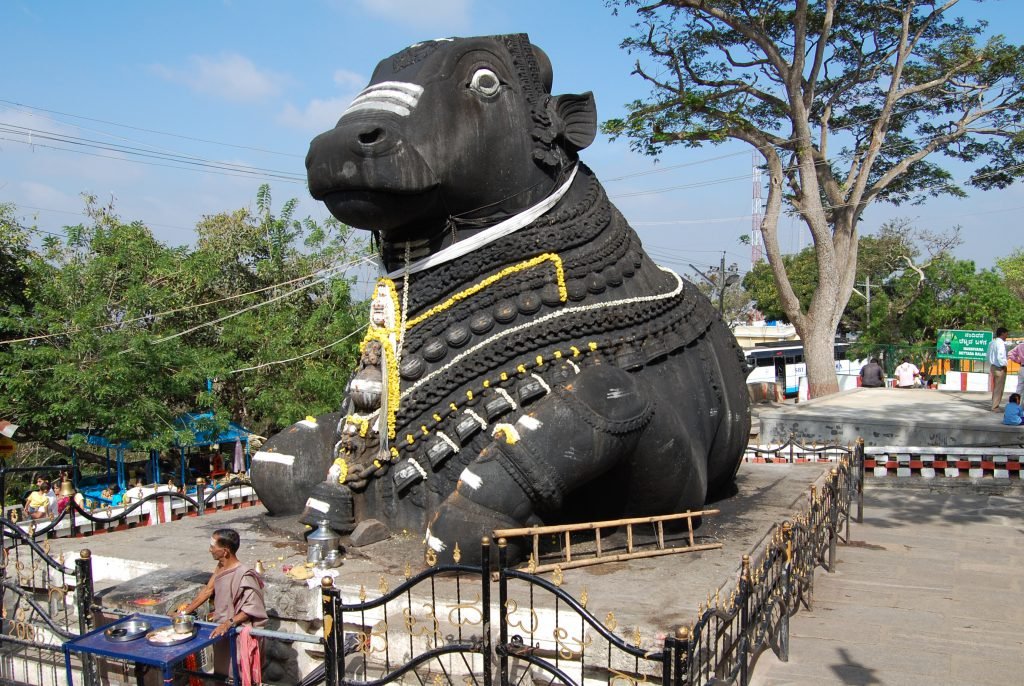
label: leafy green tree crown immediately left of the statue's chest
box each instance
[190,186,369,431]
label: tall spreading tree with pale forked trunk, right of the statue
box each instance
[603,0,1024,395]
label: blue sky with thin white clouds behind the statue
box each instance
[0,0,1024,278]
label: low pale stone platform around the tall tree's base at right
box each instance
[756,388,1024,447]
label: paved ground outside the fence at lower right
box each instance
[752,485,1024,686]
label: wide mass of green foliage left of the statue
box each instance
[0,186,366,448]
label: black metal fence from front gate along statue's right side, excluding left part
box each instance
[319,442,864,686]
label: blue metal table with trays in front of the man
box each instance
[63,613,239,686]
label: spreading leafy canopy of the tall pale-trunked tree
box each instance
[602,0,1024,198]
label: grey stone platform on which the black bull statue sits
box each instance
[49,464,831,674]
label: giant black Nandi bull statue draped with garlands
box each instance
[253,34,750,562]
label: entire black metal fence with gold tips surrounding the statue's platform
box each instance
[0,442,864,686]
